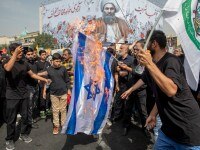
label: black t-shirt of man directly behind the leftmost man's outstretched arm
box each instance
[26,60,38,87]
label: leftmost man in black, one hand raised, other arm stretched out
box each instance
[3,43,48,150]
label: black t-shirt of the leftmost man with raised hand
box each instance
[3,60,30,99]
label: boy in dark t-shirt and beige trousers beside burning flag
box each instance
[43,53,71,135]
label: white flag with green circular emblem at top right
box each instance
[163,0,200,90]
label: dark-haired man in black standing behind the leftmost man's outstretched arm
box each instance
[24,47,39,128]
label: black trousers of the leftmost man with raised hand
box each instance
[6,98,31,140]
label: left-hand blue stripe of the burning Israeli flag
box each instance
[66,33,86,134]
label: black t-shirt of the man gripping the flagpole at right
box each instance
[142,53,200,146]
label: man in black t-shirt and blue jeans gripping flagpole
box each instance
[122,31,200,150]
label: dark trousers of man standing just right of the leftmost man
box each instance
[27,86,39,124]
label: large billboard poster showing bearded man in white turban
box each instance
[41,0,162,46]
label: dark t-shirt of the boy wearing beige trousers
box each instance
[47,66,70,96]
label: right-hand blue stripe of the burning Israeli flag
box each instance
[92,52,111,134]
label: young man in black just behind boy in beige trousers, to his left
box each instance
[36,50,51,119]
